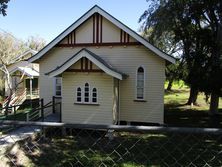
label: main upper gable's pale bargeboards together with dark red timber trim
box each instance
[29,5,175,63]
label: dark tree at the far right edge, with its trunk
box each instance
[199,0,222,115]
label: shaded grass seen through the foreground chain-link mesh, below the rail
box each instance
[3,128,222,167]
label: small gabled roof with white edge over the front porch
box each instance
[46,48,126,80]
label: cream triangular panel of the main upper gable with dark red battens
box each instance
[59,15,137,45]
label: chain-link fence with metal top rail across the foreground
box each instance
[0,121,222,167]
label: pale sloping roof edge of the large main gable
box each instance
[28,5,175,63]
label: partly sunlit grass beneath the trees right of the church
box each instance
[164,84,222,128]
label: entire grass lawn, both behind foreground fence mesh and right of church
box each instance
[0,86,222,167]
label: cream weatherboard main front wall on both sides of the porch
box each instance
[40,46,165,123]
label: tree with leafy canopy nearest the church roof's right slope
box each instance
[140,0,201,104]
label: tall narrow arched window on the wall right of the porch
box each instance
[136,67,144,99]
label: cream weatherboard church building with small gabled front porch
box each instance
[29,6,175,124]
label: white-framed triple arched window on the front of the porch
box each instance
[76,83,98,103]
